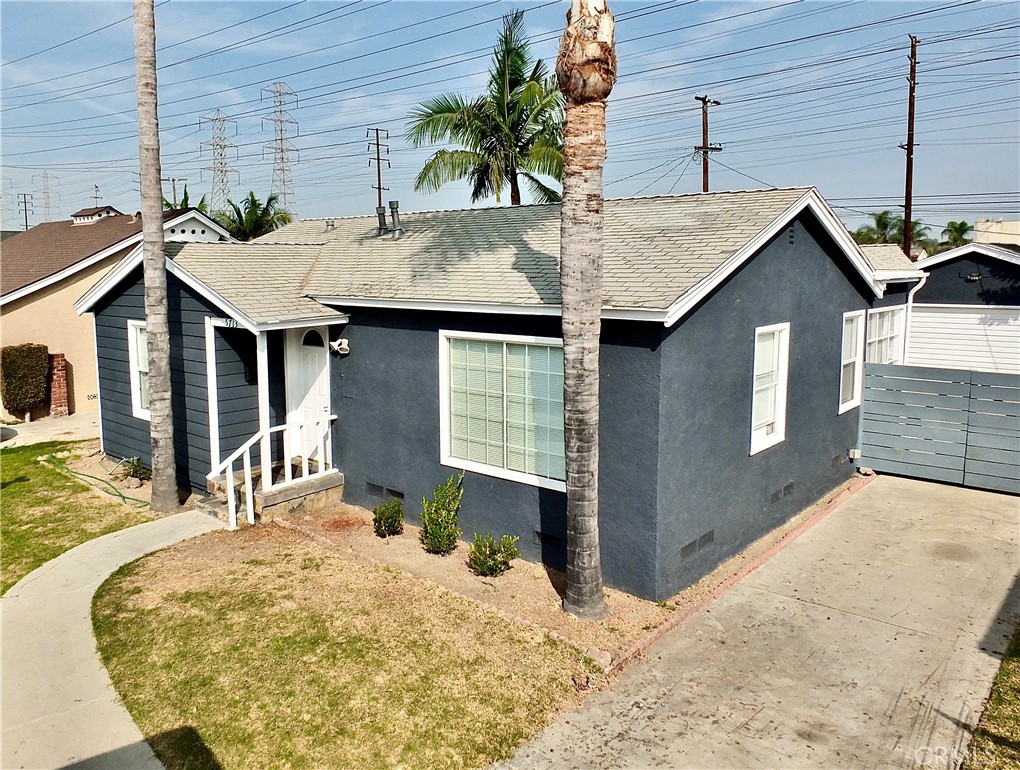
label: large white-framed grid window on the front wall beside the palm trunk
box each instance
[440,331,566,490]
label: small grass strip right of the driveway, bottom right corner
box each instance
[964,623,1020,770]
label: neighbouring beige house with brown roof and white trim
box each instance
[0,206,230,419]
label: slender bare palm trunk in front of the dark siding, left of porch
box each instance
[134,0,180,513]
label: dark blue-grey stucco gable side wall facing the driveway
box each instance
[655,214,870,599]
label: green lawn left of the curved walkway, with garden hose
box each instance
[0,442,149,593]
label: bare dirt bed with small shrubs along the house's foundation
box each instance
[275,482,850,668]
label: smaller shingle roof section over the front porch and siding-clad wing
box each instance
[166,243,344,325]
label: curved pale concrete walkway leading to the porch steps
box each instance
[0,511,223,770]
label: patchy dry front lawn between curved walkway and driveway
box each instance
[93,527,602,770]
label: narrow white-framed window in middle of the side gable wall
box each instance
[751,323,789,455]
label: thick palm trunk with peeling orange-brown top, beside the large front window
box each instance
[556,0,616,619]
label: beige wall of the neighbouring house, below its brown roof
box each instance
[0,249,128,419]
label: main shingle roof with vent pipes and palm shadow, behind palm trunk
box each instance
[269,188,811,309]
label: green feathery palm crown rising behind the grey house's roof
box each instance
[406,10,563,206]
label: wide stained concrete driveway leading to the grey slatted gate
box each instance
[506,476,1020,770]
